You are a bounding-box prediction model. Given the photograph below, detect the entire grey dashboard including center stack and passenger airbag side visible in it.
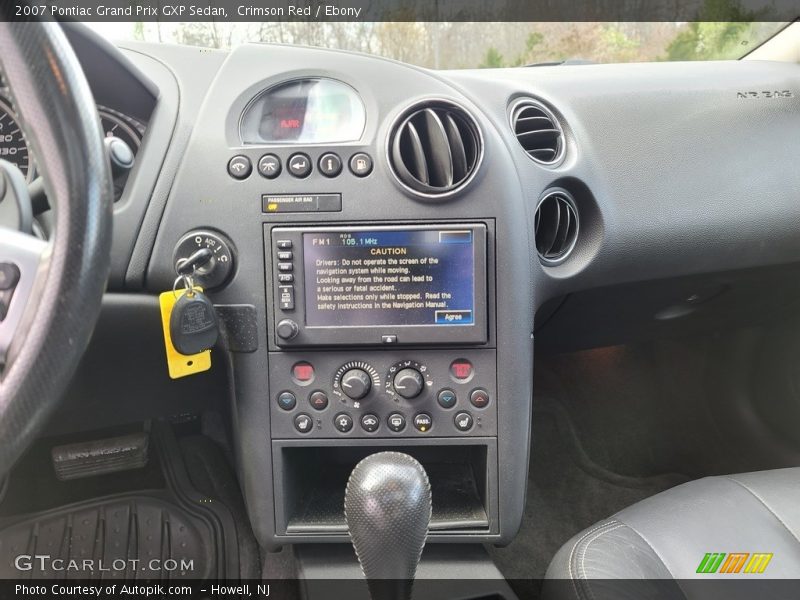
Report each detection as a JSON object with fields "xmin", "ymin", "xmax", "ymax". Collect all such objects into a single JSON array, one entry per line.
[{"xmin": 34, "ymin": 27, "xmax": 800, "ymax": 548}]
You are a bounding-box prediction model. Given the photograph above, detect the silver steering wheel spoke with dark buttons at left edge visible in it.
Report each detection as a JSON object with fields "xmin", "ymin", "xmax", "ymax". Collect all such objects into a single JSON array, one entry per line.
[{"xmin": 0, "ymin": 229, "xmax": 50, "ymax": 366}]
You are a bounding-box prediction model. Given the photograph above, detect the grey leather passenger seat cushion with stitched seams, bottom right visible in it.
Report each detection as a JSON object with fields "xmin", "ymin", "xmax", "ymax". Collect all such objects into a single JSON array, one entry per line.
[{"xmin": 545, "ymin": 468, "xmax": 800, "ymax": 599}]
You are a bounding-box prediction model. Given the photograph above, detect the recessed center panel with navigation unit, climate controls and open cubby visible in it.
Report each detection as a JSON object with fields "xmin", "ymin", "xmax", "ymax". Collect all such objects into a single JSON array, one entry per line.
[{"xmin": 264, "ymin": 221, "xmax": 497, "ymax": 536}]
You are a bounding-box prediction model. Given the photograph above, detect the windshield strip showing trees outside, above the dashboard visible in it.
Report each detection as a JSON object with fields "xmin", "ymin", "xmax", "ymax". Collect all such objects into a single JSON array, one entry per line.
[{"xmin": 88, "ymin": 22, "xmax": 785, "ymax": 69}]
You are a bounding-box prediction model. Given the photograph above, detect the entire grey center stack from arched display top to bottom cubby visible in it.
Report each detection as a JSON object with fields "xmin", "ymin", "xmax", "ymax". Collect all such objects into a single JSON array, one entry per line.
[{"xmin": 147, "ymin": 45, "xmax": 533, "ymax": 548}]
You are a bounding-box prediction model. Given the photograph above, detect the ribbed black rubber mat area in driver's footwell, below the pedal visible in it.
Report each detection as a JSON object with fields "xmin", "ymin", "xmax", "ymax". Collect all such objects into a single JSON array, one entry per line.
[{"xmin": 0, "ymin": 496, "xmax": 216, "ymax": 580}]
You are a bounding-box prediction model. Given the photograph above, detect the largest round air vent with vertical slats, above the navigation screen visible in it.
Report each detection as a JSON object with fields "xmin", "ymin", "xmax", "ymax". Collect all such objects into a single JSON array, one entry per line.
[{"xmin": 389, "ymin": 100, "xmax": 483, "ymax": 198}]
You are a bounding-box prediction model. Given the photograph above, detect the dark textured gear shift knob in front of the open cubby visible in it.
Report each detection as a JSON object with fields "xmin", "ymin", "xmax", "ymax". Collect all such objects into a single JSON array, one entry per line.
[{"xmin": 344, "ymin": 452, "xmax": 431, "ymax": 600}]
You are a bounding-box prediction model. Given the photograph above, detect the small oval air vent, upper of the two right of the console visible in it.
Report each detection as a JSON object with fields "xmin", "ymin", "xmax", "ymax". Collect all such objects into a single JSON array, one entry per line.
[{"xmin": 511, "ymin": 98, "xmax": 566, "ymax": 165}]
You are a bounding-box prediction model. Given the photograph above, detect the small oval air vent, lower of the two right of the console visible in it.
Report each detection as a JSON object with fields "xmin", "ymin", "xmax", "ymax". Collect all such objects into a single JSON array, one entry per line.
[{"xmin": 534, "ymin": 190, "xmax": 579, "ymax": 265}]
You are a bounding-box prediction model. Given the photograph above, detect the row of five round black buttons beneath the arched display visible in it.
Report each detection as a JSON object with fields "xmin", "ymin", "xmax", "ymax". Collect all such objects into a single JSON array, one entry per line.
[{"xmin": 228, "ymin": 152, "xmax": 373, "ymax": 181}]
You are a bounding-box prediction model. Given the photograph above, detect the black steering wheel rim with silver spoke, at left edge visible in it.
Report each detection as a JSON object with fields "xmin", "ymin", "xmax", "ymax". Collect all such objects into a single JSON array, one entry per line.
[{"xmin": 0, "ymin": 24, "xmax": 113, "ymax": 477}]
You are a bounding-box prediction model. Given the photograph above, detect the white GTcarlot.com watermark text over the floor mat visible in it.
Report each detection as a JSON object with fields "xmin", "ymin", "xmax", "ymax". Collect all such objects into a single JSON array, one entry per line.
[{"xmin": 14, "ymin": 554, "xmax": 194, "ymax": 574}]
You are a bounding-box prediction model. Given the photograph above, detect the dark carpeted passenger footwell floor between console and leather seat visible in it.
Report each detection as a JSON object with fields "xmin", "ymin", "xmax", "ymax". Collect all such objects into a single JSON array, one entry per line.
[{"xmin": 490, "ymin": 342, "xmax": 764, "ymax": 598}]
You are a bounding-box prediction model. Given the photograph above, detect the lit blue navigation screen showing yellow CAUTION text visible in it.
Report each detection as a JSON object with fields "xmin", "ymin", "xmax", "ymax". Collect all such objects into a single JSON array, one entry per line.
[{"xmin": 303, "ymin": 229, "xmax": 475, "ymax": 327}]
